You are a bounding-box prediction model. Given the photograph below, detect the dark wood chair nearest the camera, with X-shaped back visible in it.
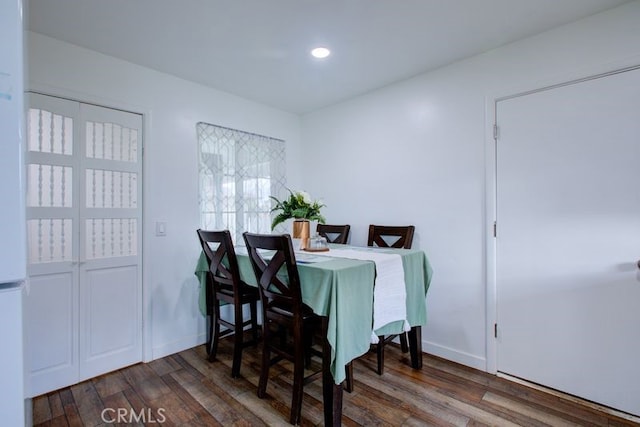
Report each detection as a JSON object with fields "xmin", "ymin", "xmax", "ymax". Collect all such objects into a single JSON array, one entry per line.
[{"xmin": 243, "ymin": 232, "xmax": 322, "ymax": 424}]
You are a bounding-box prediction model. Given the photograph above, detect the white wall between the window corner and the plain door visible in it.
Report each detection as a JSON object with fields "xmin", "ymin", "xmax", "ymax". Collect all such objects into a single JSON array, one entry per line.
[{"xmin": 302, "ymin": 1, "xmax": 640, "ymax": 370}]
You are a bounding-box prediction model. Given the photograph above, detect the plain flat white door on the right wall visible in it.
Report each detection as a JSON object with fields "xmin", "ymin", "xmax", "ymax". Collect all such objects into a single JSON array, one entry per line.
[{"xmin": 496, "ymin": 69, "xmax": 640, "ymax": 415}]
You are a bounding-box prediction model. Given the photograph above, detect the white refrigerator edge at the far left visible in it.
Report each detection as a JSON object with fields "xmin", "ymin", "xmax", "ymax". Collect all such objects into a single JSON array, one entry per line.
[{"xmin": 0, "ymin": 0, "xmax": 27, "ymax": 426}]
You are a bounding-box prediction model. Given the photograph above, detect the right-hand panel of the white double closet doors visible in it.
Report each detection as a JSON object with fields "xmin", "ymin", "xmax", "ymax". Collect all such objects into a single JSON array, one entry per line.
[{"xmin": 79, "ymin": 104, "xmax": 142, "ymax": 380}]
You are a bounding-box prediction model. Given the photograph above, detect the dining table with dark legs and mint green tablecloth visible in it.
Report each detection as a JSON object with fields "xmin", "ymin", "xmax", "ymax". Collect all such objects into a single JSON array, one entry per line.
[{"xmin": 195, "ymin": 244, "xmax": 433, "ymax": 426}]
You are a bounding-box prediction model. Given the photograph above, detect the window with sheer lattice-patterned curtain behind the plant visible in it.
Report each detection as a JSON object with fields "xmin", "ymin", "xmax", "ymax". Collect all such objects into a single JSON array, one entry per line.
[{"xmin": 196, "ymin": 122, "xmax": 285, "ymax": 242}]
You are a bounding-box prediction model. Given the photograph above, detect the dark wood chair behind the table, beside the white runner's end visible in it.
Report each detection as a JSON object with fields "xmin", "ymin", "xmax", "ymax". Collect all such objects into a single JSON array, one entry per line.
[{"xmin": 367, "ymin": 224, "xmax": 415, "ymax": 375}]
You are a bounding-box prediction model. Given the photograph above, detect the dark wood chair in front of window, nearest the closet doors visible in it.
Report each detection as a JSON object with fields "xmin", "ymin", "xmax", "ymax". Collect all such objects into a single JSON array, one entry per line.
[{"xmin": 197, "ymin": 229, "xmax": 260, "ymax": 378}]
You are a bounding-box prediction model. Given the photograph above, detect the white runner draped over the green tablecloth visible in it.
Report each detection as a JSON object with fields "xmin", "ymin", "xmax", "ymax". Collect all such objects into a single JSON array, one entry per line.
[{"xmin": 318, "ymin": 248, "xmax": 411, "ymax": 344}]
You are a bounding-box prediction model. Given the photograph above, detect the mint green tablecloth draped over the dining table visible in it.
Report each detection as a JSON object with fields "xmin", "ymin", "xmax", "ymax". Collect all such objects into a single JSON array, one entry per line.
[{"xmin": 195, "ymin": 245, "xmax": 432, "ymax": 384}]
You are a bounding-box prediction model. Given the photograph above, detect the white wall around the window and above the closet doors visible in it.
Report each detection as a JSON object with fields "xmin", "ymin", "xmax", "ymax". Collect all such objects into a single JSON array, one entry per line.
[{"xmin": 26, "ymin": 33, "xmax": 301, "ymax": 360}]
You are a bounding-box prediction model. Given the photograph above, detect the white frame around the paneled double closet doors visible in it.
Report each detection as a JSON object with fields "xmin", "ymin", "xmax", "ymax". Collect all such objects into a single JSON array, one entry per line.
[{"xmin": 25, "ymin": 84, "xmax": 153, "ymax": 363}]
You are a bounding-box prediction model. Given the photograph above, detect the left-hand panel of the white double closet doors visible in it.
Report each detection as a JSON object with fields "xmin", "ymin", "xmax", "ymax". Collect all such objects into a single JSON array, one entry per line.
[{"xmin": 24, "ymin": 95, "xmax": 80, "ymax": 396}]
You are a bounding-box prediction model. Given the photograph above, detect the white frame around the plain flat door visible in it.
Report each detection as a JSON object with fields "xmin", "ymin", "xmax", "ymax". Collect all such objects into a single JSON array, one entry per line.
[{"xmin": 484, "ymin": 56, "xmax": 640, "ymax": 374}]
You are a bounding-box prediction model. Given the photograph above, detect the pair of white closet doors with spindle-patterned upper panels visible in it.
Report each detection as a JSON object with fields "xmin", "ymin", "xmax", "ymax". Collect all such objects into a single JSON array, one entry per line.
[{"xmin": 25, "ymin": 94, "xmax": 142, "ymax": 396}]
